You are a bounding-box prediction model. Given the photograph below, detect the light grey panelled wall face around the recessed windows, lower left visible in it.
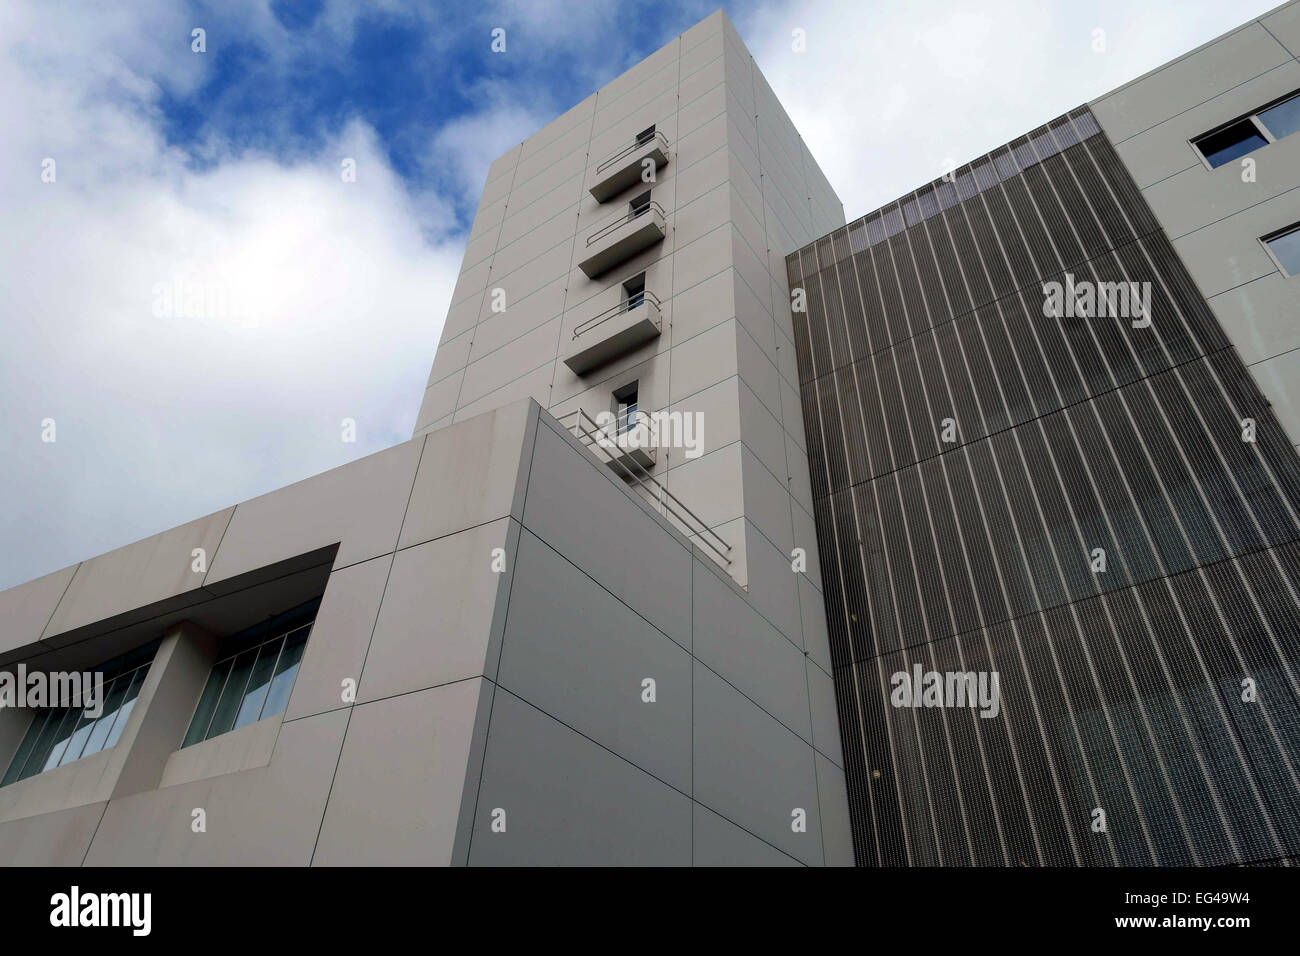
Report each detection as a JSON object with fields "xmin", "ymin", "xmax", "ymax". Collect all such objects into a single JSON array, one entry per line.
[{"xmin": 0, "ymin": 403, "xmax": 540, "ymax": 865}]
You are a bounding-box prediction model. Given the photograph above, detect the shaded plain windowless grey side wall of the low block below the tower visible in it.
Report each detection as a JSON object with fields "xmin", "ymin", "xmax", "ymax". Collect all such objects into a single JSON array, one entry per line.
[{"xmin": 469, "ymin": 403, "xmax": 853, "ymax": 865}]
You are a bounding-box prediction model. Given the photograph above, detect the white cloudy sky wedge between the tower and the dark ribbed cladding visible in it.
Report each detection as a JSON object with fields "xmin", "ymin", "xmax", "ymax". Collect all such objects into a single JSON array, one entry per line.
[{"xmin": 736, "ymin": 0, "xmax": 1277, "ymax": 220}]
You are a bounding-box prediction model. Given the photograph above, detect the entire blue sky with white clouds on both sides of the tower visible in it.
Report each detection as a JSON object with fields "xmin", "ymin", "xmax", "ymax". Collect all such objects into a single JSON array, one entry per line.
[{"xmin": 0, "ymin": 0, "xmax": 1274, "ymax": 588}]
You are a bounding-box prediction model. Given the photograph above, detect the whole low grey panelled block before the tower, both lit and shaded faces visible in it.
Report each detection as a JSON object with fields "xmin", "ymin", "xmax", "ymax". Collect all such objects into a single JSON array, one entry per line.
[{"xmin": 0, "ymin": 401, "xmax": 852, "ymax": 865}]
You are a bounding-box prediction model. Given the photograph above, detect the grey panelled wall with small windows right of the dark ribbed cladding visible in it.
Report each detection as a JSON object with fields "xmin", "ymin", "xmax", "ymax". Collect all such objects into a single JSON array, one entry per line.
[{"xmin": 1091, "ymin": 1, "xmax": 1300, "ymax": 445}]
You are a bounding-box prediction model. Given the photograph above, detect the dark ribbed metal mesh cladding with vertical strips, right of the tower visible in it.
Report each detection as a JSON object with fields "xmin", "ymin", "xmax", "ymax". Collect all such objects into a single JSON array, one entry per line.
[{"xmin": 787, "ymin": 108, "xmax": 1300, "ymax": 866}]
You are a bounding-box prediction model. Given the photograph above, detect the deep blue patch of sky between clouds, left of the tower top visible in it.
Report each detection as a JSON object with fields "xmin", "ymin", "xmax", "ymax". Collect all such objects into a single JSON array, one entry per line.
[{"xmin": 155, "ymin": 0, "xmax": 716, "ymax": 231}]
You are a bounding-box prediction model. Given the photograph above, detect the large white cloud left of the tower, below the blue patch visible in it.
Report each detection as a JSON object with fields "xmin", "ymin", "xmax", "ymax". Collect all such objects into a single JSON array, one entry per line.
[{"xmin": 0, "ymin": 4, "xmax": 462, "ymax": 588}]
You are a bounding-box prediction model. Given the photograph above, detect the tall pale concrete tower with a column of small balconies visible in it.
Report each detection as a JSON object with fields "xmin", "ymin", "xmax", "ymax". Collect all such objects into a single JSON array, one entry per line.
[{"xmin": 416, "ymin": 10, "xmax": 844, "ymax": 647}]
